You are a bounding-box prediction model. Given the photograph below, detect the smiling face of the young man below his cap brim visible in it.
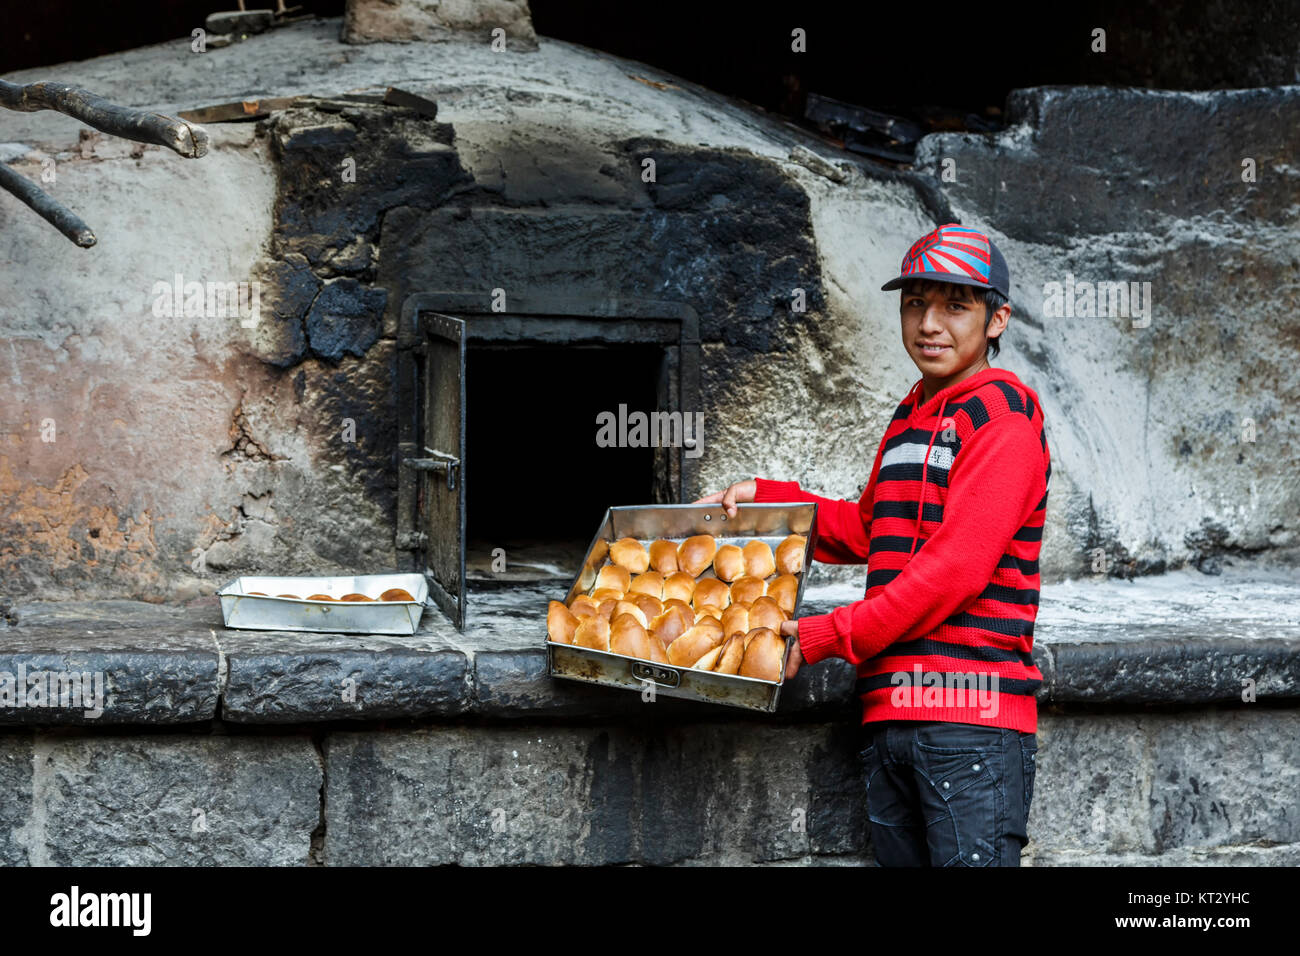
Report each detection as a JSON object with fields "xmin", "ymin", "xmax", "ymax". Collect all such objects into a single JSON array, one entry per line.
[{"xmin": 900, "ymin": 284, "xmax": 993, "ymax": 382}]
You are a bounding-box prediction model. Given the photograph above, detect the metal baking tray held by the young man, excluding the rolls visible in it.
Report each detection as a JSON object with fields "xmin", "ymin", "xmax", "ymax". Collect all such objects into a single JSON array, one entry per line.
[{"xmin": 546, "ymin": 502, "xmax": 816, "ymax": 713}]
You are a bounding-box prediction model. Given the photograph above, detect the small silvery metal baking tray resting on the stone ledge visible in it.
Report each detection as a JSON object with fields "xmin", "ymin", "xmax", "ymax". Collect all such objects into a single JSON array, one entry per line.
[{"xmin": 217, "ymin": 574, "xmax": 429, "ymax": 633}]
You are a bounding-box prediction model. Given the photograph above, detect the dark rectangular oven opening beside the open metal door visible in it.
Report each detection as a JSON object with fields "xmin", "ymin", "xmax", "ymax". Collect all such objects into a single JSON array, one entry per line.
[{"xmin": 465, "ymin": 342, "xmax": 676, "ymax": 589}]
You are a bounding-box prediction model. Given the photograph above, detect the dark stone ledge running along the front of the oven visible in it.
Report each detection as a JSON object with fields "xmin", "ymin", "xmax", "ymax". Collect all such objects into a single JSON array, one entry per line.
[{"xmin": 0, "ymin": 598, "xmax": 1300, "ymax": 724}]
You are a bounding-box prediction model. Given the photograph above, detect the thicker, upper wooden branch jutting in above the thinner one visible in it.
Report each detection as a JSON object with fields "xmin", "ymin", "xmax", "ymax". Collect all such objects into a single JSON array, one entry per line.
[{"xmin": 0, "ymin": 79, "xmax": 208, "ymax": 158}]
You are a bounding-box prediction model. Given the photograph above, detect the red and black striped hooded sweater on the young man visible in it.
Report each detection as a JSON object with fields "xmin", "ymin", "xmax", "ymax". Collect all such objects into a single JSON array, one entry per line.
[{"xmin": 754, "ymin": 368, "xmax": 1052, "ymax": 734}]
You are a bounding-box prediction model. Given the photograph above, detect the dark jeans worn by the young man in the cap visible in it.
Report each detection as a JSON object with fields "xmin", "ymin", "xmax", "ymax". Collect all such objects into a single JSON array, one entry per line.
[{"xmin": 858, "ymin": 721, "xmax": 1039, "ymax": 866}]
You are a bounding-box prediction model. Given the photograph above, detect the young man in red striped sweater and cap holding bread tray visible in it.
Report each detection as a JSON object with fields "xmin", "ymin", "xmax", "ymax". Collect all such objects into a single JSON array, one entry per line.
[{"xmin": 699, "ymin": 224, "xmax": 1052, "ymax": 866}]
